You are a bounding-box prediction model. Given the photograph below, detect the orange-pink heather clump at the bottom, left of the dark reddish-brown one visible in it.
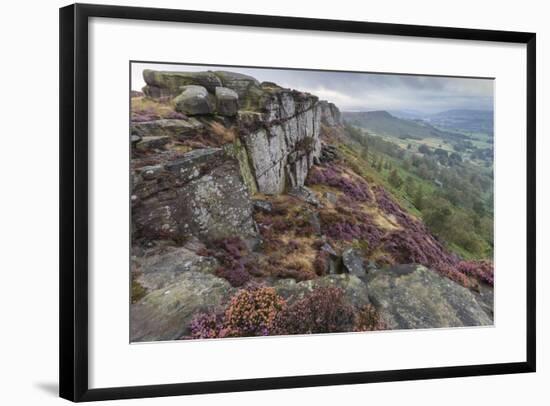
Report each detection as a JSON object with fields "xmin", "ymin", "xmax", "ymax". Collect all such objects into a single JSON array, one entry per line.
[{"xmin": 224, "ymin": 287, "xmax": 286, "ymax": 337}]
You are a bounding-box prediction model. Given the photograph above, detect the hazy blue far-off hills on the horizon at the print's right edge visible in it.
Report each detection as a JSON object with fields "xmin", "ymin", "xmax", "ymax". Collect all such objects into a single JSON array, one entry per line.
[{"xmin": 423, "ymin": 109, "xmax": 494, "ymax": 135}]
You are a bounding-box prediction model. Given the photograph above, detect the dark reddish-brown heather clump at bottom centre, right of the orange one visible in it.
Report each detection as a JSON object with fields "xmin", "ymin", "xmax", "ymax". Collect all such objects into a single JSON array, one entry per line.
[{"xmin": 273, "ymin": 287, "xmax": 354, "ymax": 334}]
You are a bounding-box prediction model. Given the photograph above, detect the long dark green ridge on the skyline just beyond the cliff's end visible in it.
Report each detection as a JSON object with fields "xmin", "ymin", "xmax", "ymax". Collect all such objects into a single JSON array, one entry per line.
[{"xmin": 343, "ymin": 111, "xmax": 463, "ymax": 140}]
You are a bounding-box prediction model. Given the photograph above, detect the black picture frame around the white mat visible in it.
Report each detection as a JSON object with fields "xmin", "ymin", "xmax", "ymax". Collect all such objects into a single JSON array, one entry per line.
[{"xmin": 59, "ymin": 4, "xmax": 536, "ymax": 402}]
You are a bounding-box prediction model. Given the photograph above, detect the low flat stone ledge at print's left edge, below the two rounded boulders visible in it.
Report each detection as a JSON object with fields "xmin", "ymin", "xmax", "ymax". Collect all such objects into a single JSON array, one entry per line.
[{"xmin": 131, "ymin": 118, "xmax": 204, "ymax": 139}]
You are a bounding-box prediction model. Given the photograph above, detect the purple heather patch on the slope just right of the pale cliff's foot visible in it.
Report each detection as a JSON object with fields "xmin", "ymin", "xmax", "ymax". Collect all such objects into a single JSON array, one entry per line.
[{"xmin": 306, "ymin": 164, "xmax": 371, "ymax": 202}]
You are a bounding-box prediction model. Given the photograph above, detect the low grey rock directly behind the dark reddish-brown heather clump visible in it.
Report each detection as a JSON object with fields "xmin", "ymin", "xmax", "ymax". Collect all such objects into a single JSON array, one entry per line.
[{"xmin": 273, "ymin": 274, "xmax": 370, "ymax": 308}]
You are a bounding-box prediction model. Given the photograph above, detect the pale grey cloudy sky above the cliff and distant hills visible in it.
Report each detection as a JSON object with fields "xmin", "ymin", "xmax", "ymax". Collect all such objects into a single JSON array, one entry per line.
[{"xmin": 132, "ymin": 63, "xmax": 494, "ymax": 113}]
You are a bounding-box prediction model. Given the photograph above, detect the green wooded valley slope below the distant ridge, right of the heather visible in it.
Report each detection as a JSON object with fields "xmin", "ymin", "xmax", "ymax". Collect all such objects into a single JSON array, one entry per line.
[{"xmin": 339, "ymin": 125, "xmax": 493, "ymax": 259}]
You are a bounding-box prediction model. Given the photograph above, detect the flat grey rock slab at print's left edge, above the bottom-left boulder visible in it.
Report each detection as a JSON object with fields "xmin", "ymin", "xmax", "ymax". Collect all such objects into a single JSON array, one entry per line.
[{"xmin": 132, "ymin": 247, "xmax": 219, "ymax": 290}]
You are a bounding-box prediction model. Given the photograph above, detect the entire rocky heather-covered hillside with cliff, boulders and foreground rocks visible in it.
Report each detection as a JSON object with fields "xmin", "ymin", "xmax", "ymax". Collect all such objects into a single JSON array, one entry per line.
[{"xmin": 131, "ymin": 71, "xmax": 493, "ymax": 341}]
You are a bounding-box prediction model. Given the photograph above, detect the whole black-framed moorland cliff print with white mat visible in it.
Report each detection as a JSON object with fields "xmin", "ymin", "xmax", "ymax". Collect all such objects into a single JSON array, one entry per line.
[{"xmin": 60, "ymin": 4, "xmax": 536, "ymax": 401}]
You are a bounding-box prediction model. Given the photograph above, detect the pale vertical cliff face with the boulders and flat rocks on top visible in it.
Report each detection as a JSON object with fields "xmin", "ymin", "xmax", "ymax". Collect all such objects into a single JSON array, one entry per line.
[{"xmin": 134, "ymin": 70, "xmax": 339, "ymax": 194}]
